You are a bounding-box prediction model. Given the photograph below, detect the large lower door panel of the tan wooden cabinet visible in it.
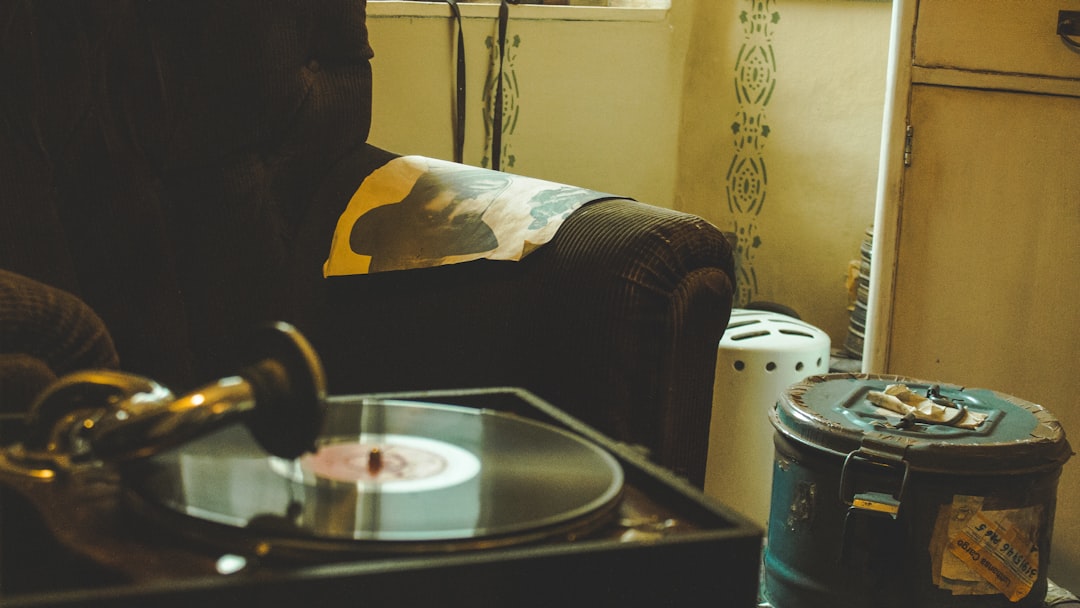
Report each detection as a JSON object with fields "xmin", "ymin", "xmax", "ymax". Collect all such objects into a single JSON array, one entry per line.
[{"xmin": 888, "ymin": 84, "xmax": 1080, "ymax": 411}]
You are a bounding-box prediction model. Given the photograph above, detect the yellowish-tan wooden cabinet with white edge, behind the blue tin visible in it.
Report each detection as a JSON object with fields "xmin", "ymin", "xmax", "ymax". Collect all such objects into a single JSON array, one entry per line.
[{"xmin": 864, "ymin": 0, "xmax": 1080, "ymax": 585}]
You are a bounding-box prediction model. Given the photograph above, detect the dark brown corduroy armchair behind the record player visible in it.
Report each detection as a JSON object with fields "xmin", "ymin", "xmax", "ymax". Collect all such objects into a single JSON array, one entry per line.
[{"xmin": 0, "ymin": 0, "xmax": 733, "ymax": 485}]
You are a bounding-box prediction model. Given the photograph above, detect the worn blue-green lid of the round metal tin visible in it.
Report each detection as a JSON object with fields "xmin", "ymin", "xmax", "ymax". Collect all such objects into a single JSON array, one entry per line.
[{"xmin": 770, "ymin": 374, "xmax": 1072, "ymax": 474}]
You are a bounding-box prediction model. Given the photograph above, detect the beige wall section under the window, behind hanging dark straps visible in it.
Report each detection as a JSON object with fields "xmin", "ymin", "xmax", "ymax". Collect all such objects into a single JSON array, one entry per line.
[{"xmin": 368, "ymin": 6, "xmax": 681, "ymax": 207}]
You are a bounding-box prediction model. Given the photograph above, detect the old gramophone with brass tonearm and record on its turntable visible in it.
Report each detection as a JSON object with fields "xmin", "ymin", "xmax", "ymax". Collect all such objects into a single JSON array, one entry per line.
[{"xmin": 0, "ymin": 324, "xmax": 761, "ymax": 607}]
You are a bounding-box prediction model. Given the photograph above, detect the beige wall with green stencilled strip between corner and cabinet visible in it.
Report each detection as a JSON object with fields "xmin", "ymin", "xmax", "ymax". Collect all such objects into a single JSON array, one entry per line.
[{"xmin": 677, "ymin": 0, "xmax": 891, "ymax": 346}]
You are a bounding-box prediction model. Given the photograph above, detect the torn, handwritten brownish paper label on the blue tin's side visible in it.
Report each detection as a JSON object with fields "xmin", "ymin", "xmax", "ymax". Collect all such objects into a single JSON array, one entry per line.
[{"xmin": 931, "ymin": 496, "xmax": 1042, "ymax": 602}]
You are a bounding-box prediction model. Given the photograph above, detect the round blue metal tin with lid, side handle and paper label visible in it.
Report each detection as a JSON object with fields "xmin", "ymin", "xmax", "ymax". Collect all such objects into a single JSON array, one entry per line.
[{"xmin": 764, "ymin": 374, "xmax": 1071, "ymax": 608}]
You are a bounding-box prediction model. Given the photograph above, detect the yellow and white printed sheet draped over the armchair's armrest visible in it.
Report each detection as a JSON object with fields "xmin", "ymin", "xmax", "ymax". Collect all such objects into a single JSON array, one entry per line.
[{"xmin": 323, "ymin": 157, "xmax": 612, "ymax": 276}]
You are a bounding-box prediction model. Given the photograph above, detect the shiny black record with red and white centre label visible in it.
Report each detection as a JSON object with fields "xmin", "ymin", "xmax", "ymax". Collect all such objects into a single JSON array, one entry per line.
[{"xmin": 124, "ymin": 402, "xmax": 623, "ymax": 553}]
